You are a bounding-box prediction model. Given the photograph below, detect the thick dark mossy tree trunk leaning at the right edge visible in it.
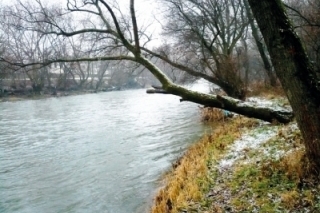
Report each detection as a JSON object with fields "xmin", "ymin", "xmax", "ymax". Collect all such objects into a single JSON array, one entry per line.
[{"xmin": 249, "ymin": 0, "xmax": 320, "ymax": 171}]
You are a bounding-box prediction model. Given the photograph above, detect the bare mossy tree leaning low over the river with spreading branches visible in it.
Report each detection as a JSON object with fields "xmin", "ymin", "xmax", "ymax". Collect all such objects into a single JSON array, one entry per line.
[{"xmin": 2, "ymin": 0, "xmax": 293, "ymax": 123}]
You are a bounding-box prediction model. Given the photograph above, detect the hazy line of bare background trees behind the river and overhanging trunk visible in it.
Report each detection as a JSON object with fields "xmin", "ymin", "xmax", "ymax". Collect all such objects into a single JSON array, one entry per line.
[{"xmin": 0, "ymin": 0, "xmax": 320, "ymax": 100}]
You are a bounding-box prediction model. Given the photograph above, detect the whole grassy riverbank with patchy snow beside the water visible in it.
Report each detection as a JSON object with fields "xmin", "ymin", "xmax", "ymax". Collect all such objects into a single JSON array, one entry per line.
[{"xmin": 151, "ymin": 85, "xmax": 320, "ymax": 213}]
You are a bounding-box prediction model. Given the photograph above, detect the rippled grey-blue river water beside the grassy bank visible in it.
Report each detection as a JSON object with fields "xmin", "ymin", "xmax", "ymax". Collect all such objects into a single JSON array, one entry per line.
[{"xmin": 0, "ymin": 90, "xmax": 204, "ymax": 213}]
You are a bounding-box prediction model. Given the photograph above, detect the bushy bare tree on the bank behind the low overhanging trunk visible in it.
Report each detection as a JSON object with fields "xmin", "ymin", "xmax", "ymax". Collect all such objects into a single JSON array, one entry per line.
[{"xmin": 149, "ymin": 0, "xmax": 248, "ymax": 99}]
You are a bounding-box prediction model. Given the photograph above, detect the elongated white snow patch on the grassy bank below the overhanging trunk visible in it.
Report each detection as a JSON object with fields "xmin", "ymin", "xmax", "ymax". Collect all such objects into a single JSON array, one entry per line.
[{"xmin": 217, "ymin": 125, "xmax": 279, "ymax": 171}]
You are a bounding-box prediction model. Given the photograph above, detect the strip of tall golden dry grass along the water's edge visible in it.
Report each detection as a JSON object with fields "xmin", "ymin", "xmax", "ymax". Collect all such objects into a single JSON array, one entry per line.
[{"xmin": 151, "ymin": 117, "xmax": 257, "ymax": 213}]
